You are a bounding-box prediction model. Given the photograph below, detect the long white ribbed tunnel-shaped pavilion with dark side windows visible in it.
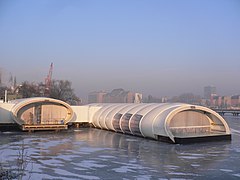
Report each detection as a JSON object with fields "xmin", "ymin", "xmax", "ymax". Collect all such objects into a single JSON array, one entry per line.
[{"xmin": 89, "ymin": 103, "xmax": 230, "ymax": 142}]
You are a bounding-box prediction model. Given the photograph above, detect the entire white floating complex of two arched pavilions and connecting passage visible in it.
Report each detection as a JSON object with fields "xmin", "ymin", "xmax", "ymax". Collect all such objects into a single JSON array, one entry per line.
[{"xmin": 0, "ymin": 97, "xmax": 231, "ymax": 143}]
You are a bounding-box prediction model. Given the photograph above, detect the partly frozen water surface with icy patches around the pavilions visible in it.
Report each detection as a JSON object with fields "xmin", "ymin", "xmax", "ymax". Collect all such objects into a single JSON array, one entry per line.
[{"xmin": 0, "ymin": 116, "xmax": 240, "ymax": 179}]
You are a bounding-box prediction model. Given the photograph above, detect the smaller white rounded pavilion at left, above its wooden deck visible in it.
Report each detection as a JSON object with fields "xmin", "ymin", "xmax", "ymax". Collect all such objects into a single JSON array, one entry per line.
[{"xmin": 11, "ymin": 97, "xmax": 73, "ymax": 125}]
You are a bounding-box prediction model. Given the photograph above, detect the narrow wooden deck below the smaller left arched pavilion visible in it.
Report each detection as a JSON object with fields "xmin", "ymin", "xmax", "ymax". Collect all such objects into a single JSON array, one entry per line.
[{"xmin": 21, "ymin": 124, "xmax": 68, "ymax": 131}]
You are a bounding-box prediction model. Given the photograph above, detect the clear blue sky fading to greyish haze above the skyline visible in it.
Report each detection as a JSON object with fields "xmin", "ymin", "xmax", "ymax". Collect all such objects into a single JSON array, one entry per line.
[{"xmin": 0, "ymin": 0, "xmax": 240, "ymax": 98}]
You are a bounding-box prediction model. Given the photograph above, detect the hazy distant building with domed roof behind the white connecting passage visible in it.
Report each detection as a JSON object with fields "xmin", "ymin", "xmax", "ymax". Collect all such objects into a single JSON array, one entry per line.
[{"xmin": 88, "ymin": 88, "xmax": 142, "ymax": 103}]
